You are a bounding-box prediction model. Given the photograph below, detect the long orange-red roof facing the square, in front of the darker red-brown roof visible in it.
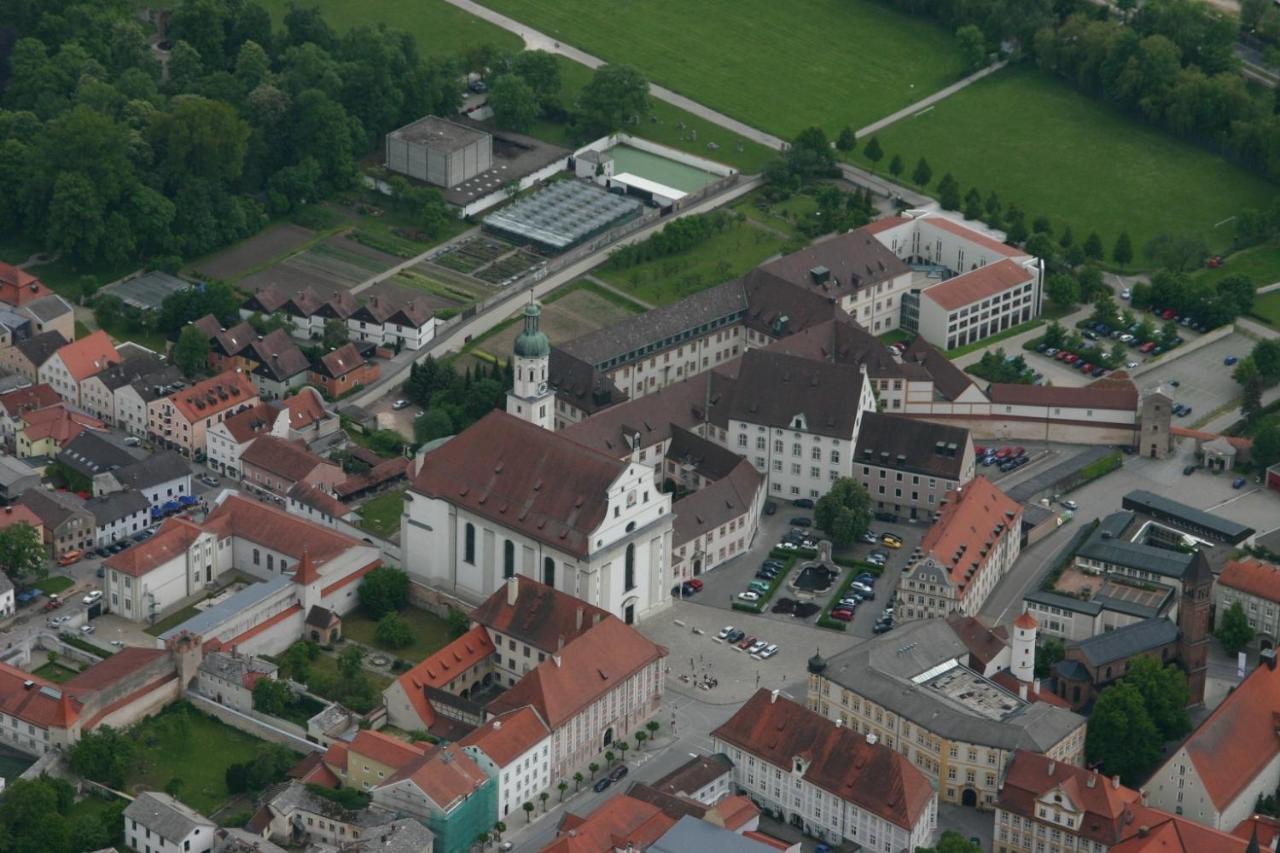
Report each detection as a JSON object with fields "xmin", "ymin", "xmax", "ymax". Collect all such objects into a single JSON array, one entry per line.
[{"xmin": 488, "ymin": 616, "xmax": 667, "ymax": 729}]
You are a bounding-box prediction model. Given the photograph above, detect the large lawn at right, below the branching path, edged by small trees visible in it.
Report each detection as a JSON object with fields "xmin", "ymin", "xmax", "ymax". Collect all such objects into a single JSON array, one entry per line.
[{"xmin": 859, "ymin": 68, "xmax": 1276, "ymax": 266}]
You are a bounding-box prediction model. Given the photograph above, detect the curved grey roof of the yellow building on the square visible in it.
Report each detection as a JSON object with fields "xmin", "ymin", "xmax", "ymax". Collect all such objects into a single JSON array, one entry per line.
[{"xmin": 823, "ymin": 619, "xmax": 1084, "ymax": 752}]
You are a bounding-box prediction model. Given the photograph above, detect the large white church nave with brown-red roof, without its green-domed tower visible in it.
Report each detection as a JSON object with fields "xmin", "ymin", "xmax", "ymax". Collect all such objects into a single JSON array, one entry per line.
[{"xmin": 401, "ymin": 411, "xmax": 673, "ymax": 624}]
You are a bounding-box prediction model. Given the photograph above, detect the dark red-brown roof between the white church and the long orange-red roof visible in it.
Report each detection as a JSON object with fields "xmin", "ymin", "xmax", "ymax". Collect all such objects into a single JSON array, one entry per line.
[{"xmin": 471, "ymin": 575, "xmax": 609, "ymax": 652}]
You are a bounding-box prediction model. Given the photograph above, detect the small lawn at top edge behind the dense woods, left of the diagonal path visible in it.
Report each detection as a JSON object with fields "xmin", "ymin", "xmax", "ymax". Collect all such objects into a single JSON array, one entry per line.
[{"xmin": 260, "ymin": 0, "xmax": 521, "ymax": 56}]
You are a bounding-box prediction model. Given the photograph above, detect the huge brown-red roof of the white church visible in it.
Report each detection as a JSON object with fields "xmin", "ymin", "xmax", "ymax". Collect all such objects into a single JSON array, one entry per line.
[{"xmin": 412, "ymin": 411, "xmax": 626, "ymax": 557}]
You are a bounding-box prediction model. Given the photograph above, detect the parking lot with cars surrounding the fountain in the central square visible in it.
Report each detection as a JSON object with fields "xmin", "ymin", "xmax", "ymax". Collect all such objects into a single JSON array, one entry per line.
[{"xmin": 690, "ymin": 503, "xmax": 927, "ymax": 637}]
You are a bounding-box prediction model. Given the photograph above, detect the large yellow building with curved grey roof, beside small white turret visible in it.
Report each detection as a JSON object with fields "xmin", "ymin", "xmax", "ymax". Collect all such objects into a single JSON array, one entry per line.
[{"xmin": 808, "ymin": 616, "xmax": 1085, "ymax": 809}]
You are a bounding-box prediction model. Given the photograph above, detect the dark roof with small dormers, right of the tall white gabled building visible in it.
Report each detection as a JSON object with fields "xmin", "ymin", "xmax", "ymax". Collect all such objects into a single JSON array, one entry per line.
[{"xmin": 854, "ymin": 412, "xmax": 969, "ymax": 480}]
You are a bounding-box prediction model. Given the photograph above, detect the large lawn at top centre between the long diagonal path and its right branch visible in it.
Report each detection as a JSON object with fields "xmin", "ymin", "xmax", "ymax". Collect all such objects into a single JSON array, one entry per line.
[{"xmin": 481, "ymin": 0, "xmax": 964, "ymax": 137}]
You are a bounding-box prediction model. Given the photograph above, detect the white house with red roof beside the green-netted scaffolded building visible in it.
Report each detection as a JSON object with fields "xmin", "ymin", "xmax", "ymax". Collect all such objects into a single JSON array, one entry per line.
[{"xmin": 458, "ymin": 701, "xmax": 554, "ymax": 821}]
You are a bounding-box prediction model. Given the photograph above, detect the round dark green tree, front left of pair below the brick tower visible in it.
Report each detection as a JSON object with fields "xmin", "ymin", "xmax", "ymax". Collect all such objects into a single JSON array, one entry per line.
[{"xmin": 1084, "ymin": 679, "xmax": 1164, "ymax": 785}]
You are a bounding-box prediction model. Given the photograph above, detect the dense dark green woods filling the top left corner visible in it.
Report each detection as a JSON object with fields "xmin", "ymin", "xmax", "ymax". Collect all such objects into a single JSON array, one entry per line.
[{"xmin": 0, "ymin": 0, "xmax": 461, "ymax": 265}]
